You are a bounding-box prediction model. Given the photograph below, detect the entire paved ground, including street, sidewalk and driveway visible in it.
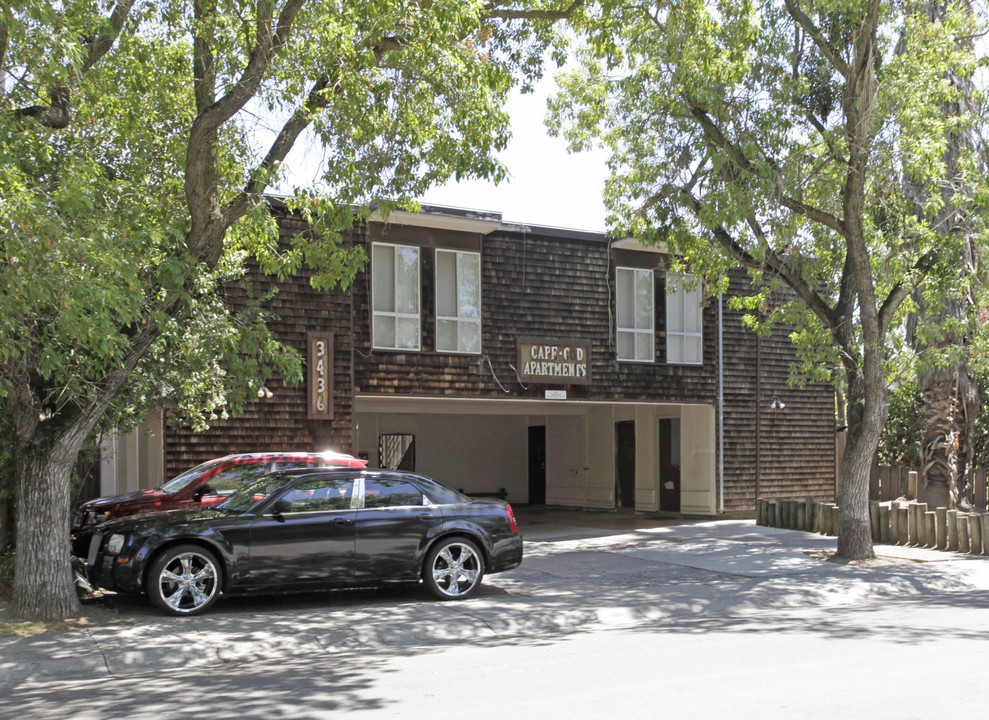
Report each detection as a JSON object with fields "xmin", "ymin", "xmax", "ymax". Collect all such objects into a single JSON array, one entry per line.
[{"xmin": 0, "ymin": 512, "xmax": 989, "ymax": 719}]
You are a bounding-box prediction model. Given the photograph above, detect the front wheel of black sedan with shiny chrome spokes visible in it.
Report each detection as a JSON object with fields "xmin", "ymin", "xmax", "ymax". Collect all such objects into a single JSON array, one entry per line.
[{"xmin": 145, "ymin": 545, "xmax": 222, "ymax": 615}]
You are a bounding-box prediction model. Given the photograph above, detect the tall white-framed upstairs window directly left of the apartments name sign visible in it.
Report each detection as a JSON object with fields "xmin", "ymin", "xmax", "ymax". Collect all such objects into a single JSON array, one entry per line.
[{"xmin": 436, "ymin": 250, "xmax": 481, "ymax": 353}]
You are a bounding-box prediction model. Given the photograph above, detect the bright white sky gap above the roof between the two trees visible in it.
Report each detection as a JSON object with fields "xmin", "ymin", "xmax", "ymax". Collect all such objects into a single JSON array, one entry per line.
[{"xmin": 419, "ymin": 73, "xmax": 607, "ymax": 232}]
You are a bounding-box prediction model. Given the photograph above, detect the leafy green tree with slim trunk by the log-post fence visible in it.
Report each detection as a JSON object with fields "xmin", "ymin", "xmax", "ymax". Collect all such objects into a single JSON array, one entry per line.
[{"xmin": 551, "ymin": 0, "xmax": 986, "ymax": 558}]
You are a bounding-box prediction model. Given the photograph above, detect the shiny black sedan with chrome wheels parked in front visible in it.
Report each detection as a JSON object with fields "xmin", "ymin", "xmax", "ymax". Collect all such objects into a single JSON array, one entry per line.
[{"xmin": 86, "ymin": 469, "xmax": 522, "ymax": 615}]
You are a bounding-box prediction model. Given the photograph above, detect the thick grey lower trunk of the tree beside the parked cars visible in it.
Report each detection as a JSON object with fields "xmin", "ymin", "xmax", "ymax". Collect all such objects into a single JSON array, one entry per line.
[{"xmin": 11, "ymin": 439, "xmax": 81, "ymax": 620}]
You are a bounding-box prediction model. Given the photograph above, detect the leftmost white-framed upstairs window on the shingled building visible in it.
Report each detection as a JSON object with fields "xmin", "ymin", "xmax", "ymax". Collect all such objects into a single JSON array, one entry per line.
[{"xmin": 371, "ymin": 243, "xmax": 420, "ymax": 350}]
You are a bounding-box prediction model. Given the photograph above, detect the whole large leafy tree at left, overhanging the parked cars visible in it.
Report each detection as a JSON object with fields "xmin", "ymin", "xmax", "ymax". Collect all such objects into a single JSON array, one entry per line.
[{"xmin": 0, "ymin": 0, "xmax": 582, "ymax": 618}]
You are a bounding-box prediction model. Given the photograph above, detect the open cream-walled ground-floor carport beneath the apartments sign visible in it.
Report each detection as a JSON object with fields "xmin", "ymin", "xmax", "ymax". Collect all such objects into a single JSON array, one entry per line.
[{"xmin": 354, "ymin": 394, "xmax": 717, "ymax": 515}]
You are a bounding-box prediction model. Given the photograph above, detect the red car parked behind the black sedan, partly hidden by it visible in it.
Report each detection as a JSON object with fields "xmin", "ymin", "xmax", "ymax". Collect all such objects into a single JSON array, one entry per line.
[{"xmin": 72, "ymin": 452, "xmax": 367, "ymax": 557}]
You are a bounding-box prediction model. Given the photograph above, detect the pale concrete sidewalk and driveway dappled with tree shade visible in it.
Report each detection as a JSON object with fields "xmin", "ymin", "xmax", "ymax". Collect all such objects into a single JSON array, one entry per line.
[{"xmin": 0, "ymin": 509, "xmax": 989, "ymax": 688}]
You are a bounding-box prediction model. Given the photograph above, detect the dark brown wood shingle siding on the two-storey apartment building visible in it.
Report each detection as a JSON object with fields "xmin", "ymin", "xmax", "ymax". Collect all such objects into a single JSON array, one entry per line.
[{"xmin": 165, "ymin": 205, "xmax": 835, "ymax": 513}]
